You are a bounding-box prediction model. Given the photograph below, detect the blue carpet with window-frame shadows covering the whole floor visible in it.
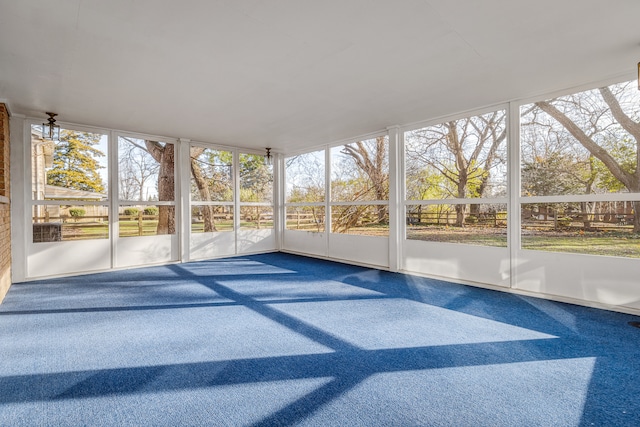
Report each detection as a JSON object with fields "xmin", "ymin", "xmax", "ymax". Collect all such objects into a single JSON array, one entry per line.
[{"xmin": 0, "ymin": 254, "xmax": 640, "ymax": 426}]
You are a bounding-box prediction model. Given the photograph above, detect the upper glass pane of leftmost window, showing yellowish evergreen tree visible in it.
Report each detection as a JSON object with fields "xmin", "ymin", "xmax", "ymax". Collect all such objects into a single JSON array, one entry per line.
[{"xmin": 31, "ymin": 125, "xmax": 109, "ymax": 200}]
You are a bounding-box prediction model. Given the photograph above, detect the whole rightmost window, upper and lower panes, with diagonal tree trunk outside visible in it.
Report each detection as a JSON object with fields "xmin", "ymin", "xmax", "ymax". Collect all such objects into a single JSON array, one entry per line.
[{"xmin": 520, "ymin": 81, "xmax": 640, "ymax": 257}]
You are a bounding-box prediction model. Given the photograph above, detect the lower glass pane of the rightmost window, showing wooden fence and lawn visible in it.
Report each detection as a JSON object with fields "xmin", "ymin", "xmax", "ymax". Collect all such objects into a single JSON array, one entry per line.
[{"xmin": 521, "ymin": 201, "xmax": 640, "ymax": 258}]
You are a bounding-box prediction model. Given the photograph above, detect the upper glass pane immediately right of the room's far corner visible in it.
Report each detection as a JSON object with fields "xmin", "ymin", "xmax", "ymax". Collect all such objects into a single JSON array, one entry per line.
[{"xmin": 285, "ymin": 151, "xmax": 325, "ymax": 203}]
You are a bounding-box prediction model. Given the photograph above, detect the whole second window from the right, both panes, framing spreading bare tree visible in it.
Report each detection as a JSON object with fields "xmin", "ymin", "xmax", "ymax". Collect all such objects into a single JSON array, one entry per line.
[{"xmin": 405, "ymin": 110, "xmax": 507, "ymax": 247}]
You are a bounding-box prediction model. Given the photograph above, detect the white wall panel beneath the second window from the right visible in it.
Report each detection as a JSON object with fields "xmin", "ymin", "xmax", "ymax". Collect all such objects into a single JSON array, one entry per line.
[{"xmin": 403, "ymin": 240, "xmax": 510, "ymax": 287}]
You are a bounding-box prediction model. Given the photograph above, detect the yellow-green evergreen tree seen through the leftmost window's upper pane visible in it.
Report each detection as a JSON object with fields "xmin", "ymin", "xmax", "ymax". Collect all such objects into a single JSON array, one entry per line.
[{"xmin": 47, "ymin": 129, "xmax": 105, "ymax": 193}]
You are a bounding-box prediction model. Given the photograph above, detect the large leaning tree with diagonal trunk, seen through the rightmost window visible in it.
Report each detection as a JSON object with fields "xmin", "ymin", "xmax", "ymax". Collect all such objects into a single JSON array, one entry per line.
[{"xmin": 535, "ymin": 82, "xmax": 640, "ymax": 233}]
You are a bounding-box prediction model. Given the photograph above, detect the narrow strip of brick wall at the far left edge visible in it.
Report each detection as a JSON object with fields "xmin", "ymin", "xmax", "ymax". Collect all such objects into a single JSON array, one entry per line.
[{"xmin": 0, "ymin": 104, "xmax": 11, "ymax": 302}]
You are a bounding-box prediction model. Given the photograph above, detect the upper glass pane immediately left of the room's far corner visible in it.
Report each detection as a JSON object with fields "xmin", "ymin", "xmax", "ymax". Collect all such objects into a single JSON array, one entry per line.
[{"xmin": 240, "ymin": 154, "xmax": 273, "ymax": 203}]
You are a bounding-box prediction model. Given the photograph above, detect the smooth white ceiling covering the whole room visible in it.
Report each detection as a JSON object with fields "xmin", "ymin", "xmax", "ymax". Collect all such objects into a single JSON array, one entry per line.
[{"xmin": 0, "ymin": 0, "xmax": 640, "ymax": 152}]
